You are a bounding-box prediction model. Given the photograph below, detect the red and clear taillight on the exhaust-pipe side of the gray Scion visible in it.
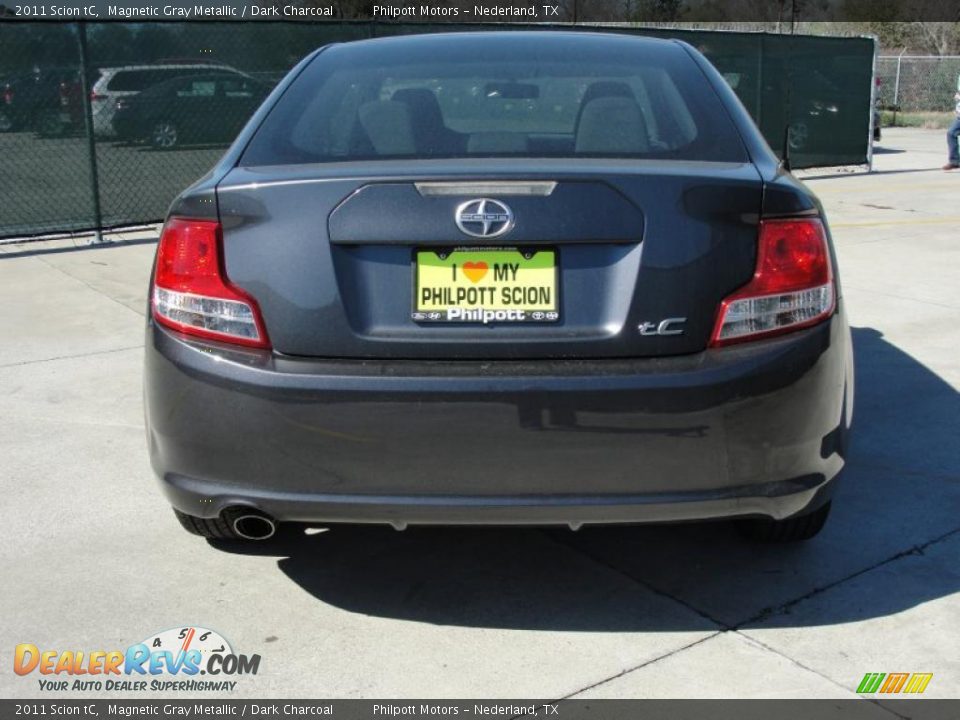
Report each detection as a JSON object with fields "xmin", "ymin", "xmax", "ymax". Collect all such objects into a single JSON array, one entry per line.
[{"xmin": 152, "ymin": 218, "xmax": 270, "ymax": 348}]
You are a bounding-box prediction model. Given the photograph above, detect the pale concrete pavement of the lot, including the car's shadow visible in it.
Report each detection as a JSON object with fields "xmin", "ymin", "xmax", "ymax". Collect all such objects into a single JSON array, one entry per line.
[{"xmin": 0, "ymin": 129, "xmax": 960, "ymax": 700}]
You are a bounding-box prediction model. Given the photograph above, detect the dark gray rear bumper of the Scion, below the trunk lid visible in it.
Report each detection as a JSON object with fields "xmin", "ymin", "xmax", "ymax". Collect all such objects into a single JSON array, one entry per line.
[{"xmin": 145, "ymin": 311, "xmax": 852, "ymax": 527}]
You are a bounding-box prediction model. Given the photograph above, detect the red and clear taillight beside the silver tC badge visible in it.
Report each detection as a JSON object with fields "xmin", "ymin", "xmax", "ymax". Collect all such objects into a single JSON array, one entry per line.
[{"xmin": 710, "ymin": 218, "xmax": 836, "ymax": 347}]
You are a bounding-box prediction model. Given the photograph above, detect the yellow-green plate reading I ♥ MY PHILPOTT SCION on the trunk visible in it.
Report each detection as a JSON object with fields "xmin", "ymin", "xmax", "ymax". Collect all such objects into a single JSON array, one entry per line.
[{"xmin": 411, "ymin": 248, "xmax": 560, "ymax": 324}]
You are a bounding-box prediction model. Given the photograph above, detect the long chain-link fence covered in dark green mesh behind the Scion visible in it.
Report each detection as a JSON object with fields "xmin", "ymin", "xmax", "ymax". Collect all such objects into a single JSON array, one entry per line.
[{"xmin": 0, "ymin": 22, "xmax": 874, "ymax": 238}]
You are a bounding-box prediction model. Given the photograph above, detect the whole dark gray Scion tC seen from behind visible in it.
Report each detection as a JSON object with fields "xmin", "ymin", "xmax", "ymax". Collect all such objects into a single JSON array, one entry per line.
[{"xmin": 145, "ymin": 31, "xmax": 853, "ymax": 540}]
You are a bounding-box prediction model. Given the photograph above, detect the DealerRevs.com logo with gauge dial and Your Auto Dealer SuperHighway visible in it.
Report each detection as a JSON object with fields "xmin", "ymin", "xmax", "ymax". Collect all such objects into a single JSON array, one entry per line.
[{"xmin": 13, "ymin": 627, "xmax": 260, "ymax": 692}]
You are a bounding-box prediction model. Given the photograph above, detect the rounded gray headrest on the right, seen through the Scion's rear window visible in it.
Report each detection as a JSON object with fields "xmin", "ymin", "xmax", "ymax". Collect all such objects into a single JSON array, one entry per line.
[{"xmin": 576, "ymin": 97, "xmax": 650, "ymax": 154}]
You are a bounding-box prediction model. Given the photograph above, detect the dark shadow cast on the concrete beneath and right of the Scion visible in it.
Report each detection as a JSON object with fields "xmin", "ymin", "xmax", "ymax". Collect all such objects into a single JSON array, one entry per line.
[{"xmin": 212, "ymin": 328, "xmax": 960, "ymax": 632}]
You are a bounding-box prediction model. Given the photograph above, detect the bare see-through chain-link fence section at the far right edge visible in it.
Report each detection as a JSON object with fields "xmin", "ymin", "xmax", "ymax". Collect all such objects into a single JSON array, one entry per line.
[{"xmin": 877, "ymin": 55, "xmax": 960, "ymax": 112}]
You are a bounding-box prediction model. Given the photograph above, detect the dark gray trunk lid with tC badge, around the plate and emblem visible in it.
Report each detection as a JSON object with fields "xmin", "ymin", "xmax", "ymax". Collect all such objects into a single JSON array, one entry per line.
[{"xmin": 218, "ymin": 159, "xmax": 762, "ymax": 359}]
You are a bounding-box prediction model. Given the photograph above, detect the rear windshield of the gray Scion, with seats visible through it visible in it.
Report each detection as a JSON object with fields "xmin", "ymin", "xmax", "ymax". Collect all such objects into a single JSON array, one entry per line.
[{"xmin": 241, "ymin": 34, "xmax": 746, "ymax": 166}]
